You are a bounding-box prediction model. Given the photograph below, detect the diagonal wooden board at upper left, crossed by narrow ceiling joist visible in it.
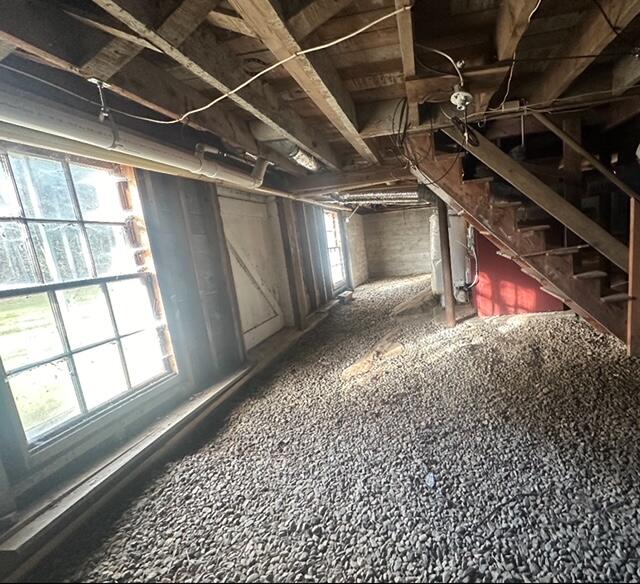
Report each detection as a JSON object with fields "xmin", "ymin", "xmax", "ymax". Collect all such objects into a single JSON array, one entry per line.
[{"xmin": 82, "ymin": 0, "xmax": 219, "ymax": 81}]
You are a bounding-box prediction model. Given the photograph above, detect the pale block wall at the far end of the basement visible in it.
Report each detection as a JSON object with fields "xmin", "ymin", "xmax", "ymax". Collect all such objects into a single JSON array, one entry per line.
[{"xmin": 362, "ymin": 209, "xmax": 435, "ymax": 278}]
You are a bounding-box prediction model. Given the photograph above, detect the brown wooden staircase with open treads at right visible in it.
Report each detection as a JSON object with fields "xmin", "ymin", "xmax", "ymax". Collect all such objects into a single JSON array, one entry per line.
[{"xmin": 420, "ymin": 155, "xmax": 631, "ymax": 341}]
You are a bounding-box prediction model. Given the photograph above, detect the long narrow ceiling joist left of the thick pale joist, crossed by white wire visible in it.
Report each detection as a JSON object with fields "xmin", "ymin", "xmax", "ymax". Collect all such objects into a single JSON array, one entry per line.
[{"xmin": 93, "ymin": 0, "xmax": 338, "ymax": 169}]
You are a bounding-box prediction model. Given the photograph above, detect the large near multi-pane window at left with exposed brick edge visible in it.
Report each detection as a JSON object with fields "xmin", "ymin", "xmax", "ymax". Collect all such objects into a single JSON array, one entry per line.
[{"xmin": 0, "ymin": 150, "xmax": 175, "ymax": 443}]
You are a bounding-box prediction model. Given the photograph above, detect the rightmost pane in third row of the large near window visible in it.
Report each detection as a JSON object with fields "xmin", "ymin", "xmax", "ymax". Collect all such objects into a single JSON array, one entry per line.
[{"xmin": 108, "ymin": 278, "xmax": 157, "ymax": 335}]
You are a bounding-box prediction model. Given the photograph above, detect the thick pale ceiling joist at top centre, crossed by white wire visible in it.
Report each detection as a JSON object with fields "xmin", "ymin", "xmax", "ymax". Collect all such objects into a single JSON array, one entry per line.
[{"xmin": 231, "ymin": 0, "xmax": 378, "ymax": 163}]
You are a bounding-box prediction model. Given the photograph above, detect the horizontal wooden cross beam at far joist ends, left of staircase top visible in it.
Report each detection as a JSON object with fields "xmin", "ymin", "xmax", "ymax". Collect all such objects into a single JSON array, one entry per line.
[{"xmin": 289, "ymin": 166, "xmax": 413, "ymax": 194}]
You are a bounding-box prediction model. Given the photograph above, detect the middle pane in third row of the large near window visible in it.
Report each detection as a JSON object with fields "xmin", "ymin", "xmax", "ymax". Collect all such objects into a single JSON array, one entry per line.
[{"xmin": 56, "ymin": 286, "xmax": 115, "ymax": 349}]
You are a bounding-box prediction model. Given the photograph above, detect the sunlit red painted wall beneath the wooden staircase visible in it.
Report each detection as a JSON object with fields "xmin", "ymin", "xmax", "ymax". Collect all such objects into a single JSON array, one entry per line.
[{"xmin": 473, "ymin": 233, "xmax": 563, "ymax": 316}]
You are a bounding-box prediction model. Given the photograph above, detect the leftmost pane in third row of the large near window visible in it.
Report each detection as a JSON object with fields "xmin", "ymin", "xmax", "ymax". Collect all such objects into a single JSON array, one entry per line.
[{"xmin": 0, "ymin": 294, "xmax": 63, "ymax": 371}]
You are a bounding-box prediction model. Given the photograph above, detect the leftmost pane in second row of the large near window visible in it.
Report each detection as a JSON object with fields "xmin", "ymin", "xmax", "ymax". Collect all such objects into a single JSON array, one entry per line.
[{"xmin": 0, "ymin": 221, "xmax": 38, "ymax": 290}]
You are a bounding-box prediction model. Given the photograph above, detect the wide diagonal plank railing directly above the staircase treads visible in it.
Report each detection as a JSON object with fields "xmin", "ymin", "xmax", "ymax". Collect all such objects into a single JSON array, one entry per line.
[{"xmin": 444, "ymin": 122, "xmax": 629, "ymax": 271}]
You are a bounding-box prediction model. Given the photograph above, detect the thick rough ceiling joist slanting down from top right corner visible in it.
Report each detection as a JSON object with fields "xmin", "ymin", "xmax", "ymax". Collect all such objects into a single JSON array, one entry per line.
[{"xmin": 529, "ymin": 0, "xmax": 640, "ymax": 104}]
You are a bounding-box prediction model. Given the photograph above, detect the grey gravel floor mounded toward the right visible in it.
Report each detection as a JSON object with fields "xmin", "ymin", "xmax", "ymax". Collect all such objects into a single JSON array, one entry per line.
[{"xmin": 34, "ymin": 278, "xmax": 640, "ymax": 582}]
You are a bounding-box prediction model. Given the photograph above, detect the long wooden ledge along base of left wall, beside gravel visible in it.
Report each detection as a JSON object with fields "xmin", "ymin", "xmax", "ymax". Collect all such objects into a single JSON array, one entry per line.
[{"xmin": 0, "ymin": 310, "xmax": 335, "ymax": 581}]
